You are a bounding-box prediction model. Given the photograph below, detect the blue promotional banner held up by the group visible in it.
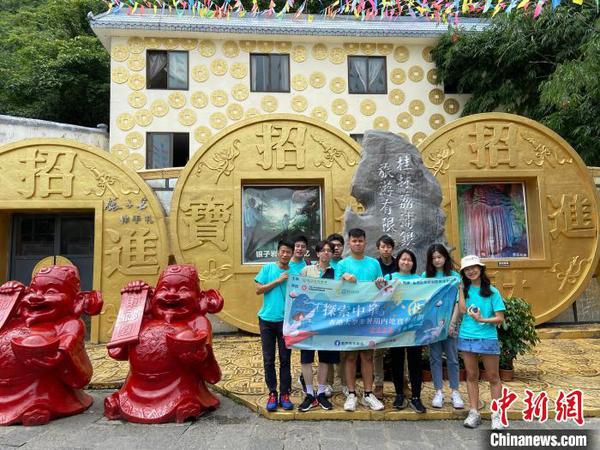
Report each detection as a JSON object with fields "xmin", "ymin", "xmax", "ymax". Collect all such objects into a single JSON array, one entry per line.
[{"xmin": 283, "ymin": 275, "xmax": 459, "ymax": 350}]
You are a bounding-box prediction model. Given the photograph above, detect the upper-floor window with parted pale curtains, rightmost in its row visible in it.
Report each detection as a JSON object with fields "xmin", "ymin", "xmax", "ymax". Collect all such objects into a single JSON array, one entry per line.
[{"xmin": 348, "ymin": 56, "xmax": 387, "ymax": 94}]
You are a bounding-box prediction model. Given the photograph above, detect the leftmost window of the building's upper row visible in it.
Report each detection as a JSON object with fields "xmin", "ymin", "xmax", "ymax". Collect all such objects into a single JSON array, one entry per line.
[{"xmin": 146, "ymin": 50, "xmax": 188, "ymax": 90}]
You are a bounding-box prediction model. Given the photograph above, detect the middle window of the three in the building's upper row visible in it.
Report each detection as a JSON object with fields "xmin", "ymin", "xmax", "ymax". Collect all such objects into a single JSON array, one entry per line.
[{"xmin": 250, "ymin": 53, "xmax": 290, "ymax": 92}]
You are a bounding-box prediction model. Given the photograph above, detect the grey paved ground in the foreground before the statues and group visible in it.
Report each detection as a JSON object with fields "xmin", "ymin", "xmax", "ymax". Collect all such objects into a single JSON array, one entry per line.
[{"xmin": 0, "ymin": 391, "xmax": 600, "ymax": 450}]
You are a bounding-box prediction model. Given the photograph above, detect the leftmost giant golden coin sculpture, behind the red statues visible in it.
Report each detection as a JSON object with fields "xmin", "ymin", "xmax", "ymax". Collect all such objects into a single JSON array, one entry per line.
[{"xmin": 0, "ymin": 139, "xmax": 169, "ymax": 342}]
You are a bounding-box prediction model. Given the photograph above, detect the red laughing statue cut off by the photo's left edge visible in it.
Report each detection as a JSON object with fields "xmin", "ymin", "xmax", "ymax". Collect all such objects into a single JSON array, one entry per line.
[{"xmin": 0, "ymin": 266, "xmax": 102, "ymax": 425}]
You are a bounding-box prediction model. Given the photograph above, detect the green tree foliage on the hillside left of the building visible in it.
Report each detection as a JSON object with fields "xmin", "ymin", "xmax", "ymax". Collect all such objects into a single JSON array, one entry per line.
[{"xmin": 0, "ymin": 0, "xmax": 110, "ymax": 126}]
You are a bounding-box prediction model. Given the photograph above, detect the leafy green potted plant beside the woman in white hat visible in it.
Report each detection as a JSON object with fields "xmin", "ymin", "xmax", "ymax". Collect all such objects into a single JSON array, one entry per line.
[{"xmin": 498, "ymin": 297, "xmax": 540, "ymax": 381}]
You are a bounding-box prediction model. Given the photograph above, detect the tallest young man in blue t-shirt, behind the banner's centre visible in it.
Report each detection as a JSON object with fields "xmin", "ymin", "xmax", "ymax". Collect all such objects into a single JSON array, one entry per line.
[{"xmin": 335, "ymin": 228, "xmax": 384, "ymax": 411}]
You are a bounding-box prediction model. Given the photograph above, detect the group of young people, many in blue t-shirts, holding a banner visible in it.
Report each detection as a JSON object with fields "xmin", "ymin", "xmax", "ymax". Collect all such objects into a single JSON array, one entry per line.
[{"xmin": 255, "ymin": 228, "xmax": 504, "ymax": 429}]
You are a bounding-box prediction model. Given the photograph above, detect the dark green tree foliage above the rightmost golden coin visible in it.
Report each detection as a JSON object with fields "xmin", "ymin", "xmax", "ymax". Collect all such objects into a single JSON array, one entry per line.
[{"xmin": 432, "ymin": 4, "xmax": 600, "ymax": 165}]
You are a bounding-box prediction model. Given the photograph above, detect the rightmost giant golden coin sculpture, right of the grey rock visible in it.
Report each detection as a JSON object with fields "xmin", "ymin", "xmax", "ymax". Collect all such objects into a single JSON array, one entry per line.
[{"xmin": 419, "ymin": 113, "xmax": 599, "ymax": 323}]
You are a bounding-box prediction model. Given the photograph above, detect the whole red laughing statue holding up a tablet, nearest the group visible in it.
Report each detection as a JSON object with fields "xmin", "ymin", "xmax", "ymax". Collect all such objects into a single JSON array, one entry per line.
[{"xmin": 104, "ymin": 265, "xmax": 223, "ymax": 423}]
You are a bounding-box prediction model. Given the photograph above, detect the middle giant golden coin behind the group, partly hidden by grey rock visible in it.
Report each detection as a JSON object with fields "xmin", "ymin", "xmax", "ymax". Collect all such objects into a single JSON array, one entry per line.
[{"xmin": 170, "ymin": 114, "xmax": 360, "ymax": 332}]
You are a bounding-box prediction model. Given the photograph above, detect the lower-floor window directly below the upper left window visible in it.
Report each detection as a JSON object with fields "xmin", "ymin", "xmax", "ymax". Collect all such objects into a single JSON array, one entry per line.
[{"xmin": 146, "ymin": 133, "xmax": 190, "ymax": 169}]
